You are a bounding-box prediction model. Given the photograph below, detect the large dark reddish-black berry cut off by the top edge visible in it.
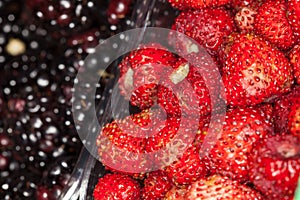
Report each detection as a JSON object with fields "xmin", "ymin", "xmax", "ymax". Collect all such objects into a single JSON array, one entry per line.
[{"xmin": 26, "ymin": 0, "xmax": 107, "ymax": 36}]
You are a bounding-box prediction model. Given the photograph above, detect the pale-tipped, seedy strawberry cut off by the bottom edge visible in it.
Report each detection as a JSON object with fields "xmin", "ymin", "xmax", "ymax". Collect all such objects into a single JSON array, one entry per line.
[{"xmin": 185, "ymin": 175, "xmax": 263, "ymax": 200}]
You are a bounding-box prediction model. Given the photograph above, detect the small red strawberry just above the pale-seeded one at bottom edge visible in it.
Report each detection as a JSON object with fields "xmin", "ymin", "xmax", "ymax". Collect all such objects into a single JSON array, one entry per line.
[{"xmin": 165, "ymin": 146, "xmax": 206, "ymax": 186}]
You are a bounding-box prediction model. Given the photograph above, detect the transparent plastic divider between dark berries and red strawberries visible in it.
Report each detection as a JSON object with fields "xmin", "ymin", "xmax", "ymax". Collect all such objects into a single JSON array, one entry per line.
[{"xmin": 59, "ymin": 0, "xmax": 156, "ymax": 200}]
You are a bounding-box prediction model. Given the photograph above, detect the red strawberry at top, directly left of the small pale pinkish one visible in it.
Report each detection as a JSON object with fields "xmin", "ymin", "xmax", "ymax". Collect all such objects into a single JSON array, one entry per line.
[{"xmin": 171, "ymin": 8, "xmax": 234, "ymax": 53}]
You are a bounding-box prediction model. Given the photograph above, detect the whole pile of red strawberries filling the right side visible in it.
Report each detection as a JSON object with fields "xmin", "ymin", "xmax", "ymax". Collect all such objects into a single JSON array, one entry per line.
[{"xmin": 93, "ymin": 0, "xmax": 300, "ymax": 200}]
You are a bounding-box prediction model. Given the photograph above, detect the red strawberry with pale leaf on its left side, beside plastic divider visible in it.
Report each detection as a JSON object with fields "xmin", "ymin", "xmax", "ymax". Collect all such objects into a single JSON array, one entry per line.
[{"xmin": 119, "ymin": 44, "xmax": 177, "ymax": 109}]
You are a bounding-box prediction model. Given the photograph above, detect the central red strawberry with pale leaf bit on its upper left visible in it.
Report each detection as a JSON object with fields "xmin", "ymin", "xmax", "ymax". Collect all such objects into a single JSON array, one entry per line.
[{"xmin": 157, "ymin": 59, "xmax": 219, "ymax": 117}]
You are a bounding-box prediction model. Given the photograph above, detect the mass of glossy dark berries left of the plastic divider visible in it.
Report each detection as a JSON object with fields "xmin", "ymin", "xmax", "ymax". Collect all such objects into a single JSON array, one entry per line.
[{"xmin": 0, "ymin": 0, "xmax": 133, "ymax": 200}]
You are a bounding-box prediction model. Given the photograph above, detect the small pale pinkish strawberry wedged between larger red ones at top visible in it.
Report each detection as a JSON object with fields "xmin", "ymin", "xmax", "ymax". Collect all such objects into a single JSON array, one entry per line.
[{"xmin": 234, "ymin": 6, "xmax": 257, "ymax": 33}]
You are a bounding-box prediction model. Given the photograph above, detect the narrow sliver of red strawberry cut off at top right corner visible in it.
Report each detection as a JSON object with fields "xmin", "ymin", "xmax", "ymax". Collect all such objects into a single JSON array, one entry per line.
[{"xmin": 287, "ymin": 0, "xmax": 300, "ymax": 40}]
